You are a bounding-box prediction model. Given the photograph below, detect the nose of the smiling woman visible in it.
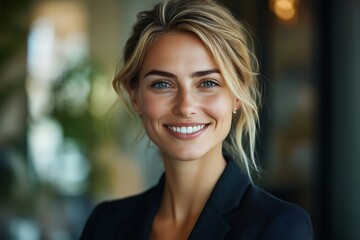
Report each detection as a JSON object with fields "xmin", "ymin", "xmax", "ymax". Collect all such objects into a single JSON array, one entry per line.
[{"xmin": 173, "ymin": 90, "xmax": 196, "ymax": 118}]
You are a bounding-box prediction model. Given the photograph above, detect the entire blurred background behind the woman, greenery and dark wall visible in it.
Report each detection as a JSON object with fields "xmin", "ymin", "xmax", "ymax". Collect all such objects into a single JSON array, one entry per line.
[{"xmin": 0, "ymin": 0, "xmax": 360, "ymax": 240}]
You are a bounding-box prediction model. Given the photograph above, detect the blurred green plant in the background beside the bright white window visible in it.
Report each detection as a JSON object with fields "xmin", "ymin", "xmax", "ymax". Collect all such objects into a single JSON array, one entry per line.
[{"xmin": 51, "ymin": 61, "xmax": 100, "ymax": 146}]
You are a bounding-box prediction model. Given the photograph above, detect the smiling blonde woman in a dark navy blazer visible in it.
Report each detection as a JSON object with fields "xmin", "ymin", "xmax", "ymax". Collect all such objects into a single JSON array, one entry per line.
[{"xmin": 81, "ymin": 0, "xmax": 312, "ymax": 240}]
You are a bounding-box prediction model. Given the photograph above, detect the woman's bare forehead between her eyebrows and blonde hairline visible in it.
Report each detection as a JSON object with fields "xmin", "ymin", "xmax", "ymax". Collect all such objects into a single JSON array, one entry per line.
[{"xmin": 140, "ymin": 32, "xmax": 217, "ymax": 72}]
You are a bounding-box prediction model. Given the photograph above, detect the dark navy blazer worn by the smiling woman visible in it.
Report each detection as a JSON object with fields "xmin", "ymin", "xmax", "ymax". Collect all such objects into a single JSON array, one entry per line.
[{"xmin": 80, "ymin": 159, "xmax": 313, "ymax": 240}]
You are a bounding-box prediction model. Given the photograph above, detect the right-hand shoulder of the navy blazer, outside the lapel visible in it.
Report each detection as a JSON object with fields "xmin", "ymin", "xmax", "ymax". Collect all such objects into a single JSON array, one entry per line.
[{"xmin": 229, "ymin": 184, "xmax": 313, "ymax": 239}]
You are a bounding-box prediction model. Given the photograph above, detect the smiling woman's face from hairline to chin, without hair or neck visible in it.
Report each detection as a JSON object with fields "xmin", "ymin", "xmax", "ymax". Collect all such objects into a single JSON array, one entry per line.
[{"xmin": 130, "ymin": 32, "xmax": 239, "ymax": 160}]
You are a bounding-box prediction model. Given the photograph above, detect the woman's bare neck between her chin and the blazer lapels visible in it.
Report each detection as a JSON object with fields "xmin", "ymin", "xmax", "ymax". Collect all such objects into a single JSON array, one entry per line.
[{"xmin": 159, "ymin": 153, "xmax": 226, "ymax": 223}]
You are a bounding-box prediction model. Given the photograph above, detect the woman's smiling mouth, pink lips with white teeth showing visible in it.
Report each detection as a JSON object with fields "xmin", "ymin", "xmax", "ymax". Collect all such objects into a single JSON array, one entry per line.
[{"xmin": 164, "ymin": 123, "xmax": 210, "ymax": 140}]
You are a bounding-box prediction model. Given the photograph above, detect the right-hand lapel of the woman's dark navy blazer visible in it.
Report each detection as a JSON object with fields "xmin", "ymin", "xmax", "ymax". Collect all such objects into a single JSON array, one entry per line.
[{"xmin": 189, "ymin": 158, "xmax": 250, "ymax": 240}]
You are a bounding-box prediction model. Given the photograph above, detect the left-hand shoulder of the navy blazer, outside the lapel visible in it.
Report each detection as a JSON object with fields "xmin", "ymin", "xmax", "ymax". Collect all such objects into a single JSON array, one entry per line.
[{"xmin": 80, "ymin": 188, "xmax": 158, "ymax": 239}]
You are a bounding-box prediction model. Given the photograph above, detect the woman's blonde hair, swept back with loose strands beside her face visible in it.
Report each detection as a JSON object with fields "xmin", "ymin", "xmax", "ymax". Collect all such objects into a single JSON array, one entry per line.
[{"xmin": 113, "ymin": 0, "xmax": 260, "ymax": 179}]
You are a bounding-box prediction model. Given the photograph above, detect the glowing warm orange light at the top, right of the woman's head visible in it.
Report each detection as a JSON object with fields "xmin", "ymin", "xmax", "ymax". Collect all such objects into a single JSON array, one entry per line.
[{"xmin": 271, "ymin": 0, "xmax": 297, "ymax": 22}]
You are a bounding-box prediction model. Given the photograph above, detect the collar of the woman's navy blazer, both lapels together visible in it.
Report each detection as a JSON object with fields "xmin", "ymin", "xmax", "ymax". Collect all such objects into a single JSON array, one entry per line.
[{"xmin": 118, "ymin": 157, "xmax": 250, "ymax": 240}]
